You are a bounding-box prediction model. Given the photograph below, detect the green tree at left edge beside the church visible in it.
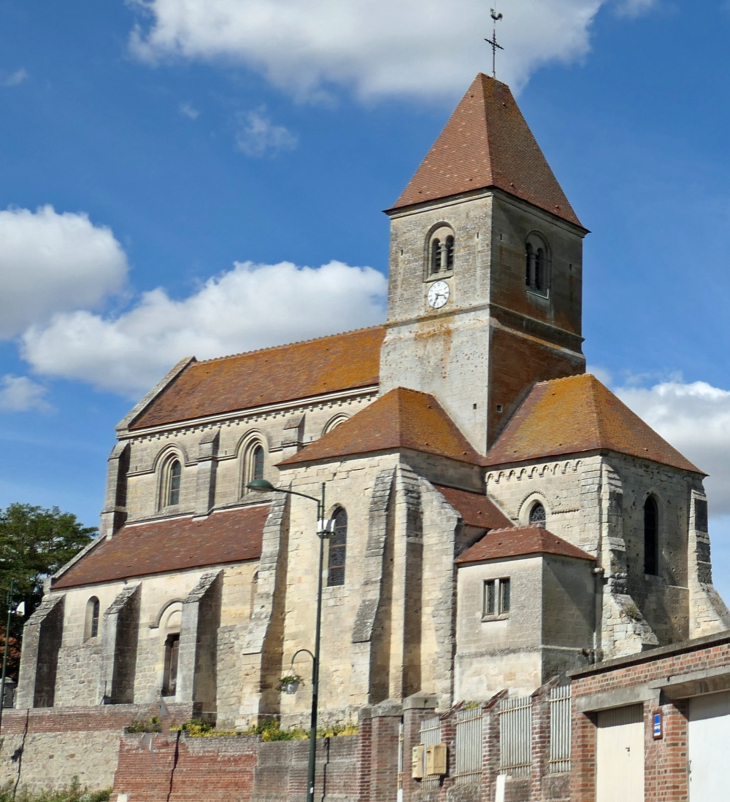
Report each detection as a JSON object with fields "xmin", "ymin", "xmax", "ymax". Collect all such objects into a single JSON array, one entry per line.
[{"xmin": 0, "ymin": 504, "xmax": 97, "ymax": 620}]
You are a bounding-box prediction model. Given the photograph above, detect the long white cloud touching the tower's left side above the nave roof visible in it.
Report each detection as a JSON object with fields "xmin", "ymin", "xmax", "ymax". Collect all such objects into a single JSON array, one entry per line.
[{"xmin": 21, "ymin": 262, "xmax": 387, "ymax": 397}]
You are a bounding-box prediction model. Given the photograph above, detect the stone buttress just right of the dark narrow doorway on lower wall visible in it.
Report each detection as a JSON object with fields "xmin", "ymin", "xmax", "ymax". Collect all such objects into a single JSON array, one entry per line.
[{"xmin": 175, "ymin": 570, "xmax": 223, "ymax": 718}]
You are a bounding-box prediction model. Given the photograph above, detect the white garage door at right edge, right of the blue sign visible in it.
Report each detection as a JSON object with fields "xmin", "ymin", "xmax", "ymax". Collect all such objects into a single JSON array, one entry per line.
[{"xmin": 688, "ymin": 693, "xmax": 730, "ymax": 802}]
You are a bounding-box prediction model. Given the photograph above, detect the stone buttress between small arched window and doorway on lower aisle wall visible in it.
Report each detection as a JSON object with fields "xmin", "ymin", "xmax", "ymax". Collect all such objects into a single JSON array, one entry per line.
[{"xmin": 99, "ymin": 585, "xmax": 142, "ymax": 704}]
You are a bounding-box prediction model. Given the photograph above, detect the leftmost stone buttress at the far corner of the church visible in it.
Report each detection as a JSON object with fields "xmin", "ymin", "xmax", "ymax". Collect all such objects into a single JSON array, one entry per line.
[{"xmin": 16, "ymin": 594, "xmax": 66, "ymax": 708}]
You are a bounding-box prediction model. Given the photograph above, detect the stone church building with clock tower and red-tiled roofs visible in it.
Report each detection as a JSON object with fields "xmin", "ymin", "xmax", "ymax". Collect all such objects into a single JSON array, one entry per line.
[{"xmin": 16, "ymin": 75, "xmax": 730, "ymax": 729}]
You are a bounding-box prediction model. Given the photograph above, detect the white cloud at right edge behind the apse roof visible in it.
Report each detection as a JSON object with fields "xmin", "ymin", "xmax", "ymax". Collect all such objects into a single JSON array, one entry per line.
[{"xmin": 614, "ymin": 381, "xmax": 730, "ymax": 516}]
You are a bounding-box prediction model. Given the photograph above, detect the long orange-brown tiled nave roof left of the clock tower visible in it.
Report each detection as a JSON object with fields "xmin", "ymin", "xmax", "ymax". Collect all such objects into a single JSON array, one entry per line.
[{"xmin": 130, "ymin": 326, "xmax": 385, "ymax": 429}]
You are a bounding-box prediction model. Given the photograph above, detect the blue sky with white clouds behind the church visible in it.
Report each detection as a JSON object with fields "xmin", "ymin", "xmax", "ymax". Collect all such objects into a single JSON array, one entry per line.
[{"xmin": 0, "ymin": 0, "xmax": 730, "ymax": 590}]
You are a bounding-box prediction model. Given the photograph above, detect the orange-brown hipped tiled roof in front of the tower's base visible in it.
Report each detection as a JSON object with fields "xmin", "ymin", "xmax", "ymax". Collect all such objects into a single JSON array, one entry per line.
[{"xmin": 279, "ymin": 387, "xmax": 482, "ymax": 467}]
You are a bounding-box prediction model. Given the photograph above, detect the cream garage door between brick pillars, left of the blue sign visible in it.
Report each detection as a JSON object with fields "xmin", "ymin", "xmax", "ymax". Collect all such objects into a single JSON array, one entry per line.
[{"xmin": 596, "ymin": 705, "xmax": 644, "ymax": 802}]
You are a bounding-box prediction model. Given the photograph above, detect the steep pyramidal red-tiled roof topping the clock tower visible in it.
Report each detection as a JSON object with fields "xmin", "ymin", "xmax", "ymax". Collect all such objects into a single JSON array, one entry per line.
[{"xmin": 386, "ymin": 73, "xmax": 581, "ymax": 226}]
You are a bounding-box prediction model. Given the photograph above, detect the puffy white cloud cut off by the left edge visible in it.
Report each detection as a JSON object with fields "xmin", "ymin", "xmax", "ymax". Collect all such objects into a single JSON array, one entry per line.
[{"xmin": 0, "ymin": 206, "xmax": 127, "ymax": 338}]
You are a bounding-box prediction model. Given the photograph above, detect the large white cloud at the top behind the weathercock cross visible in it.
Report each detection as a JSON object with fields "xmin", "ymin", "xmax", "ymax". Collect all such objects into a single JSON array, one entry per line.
[{"xmin": 130, "ymin": 0, "xmax": 649, "ymax": 99}]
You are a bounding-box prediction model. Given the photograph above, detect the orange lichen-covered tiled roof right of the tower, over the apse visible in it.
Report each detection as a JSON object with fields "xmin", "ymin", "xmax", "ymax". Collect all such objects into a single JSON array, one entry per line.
[{"xmin": 486, "ymin": 373, "xmax": 701, "ymax": 473}]
